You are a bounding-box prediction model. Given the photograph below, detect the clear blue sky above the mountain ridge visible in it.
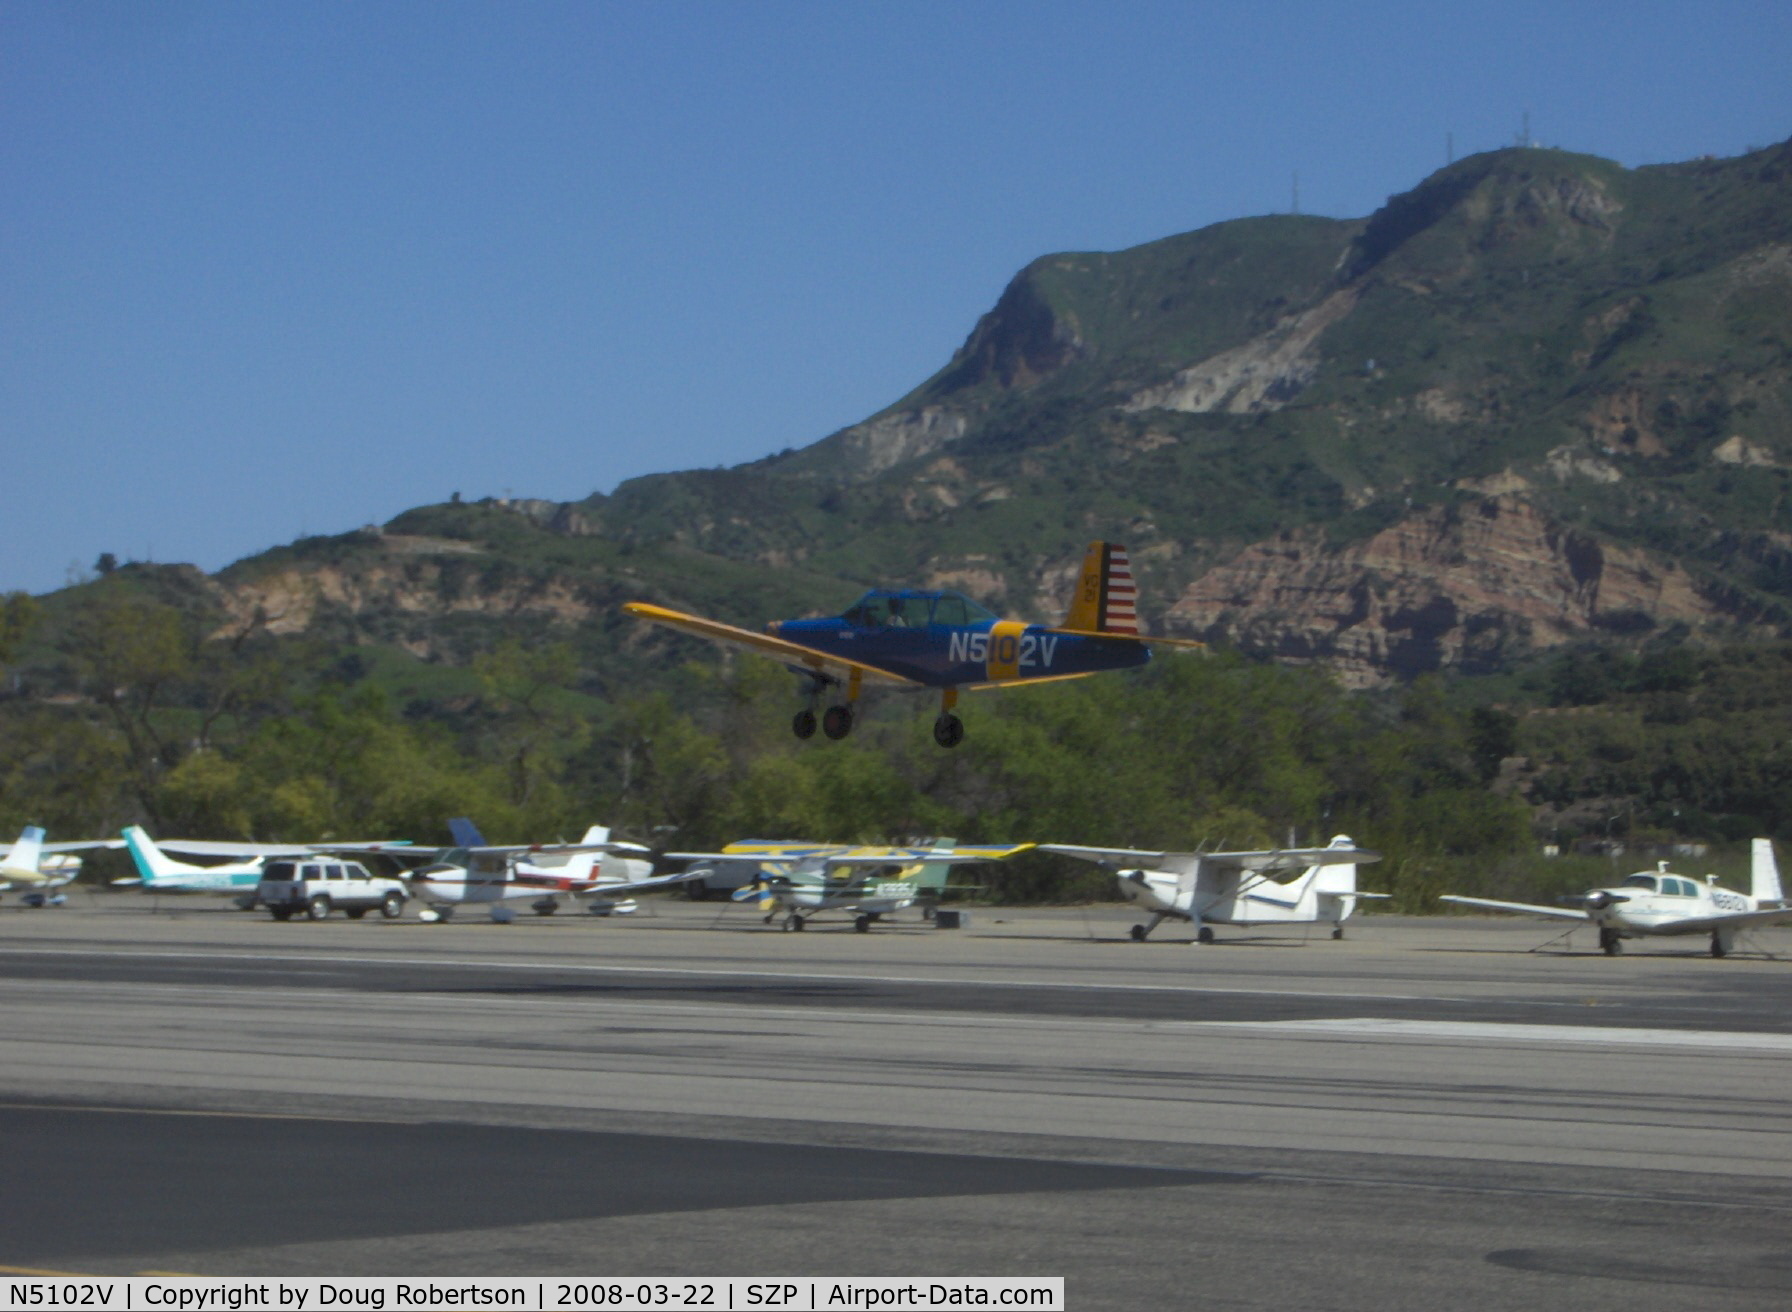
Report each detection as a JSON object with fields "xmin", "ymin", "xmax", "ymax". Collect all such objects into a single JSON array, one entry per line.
[{"xmin": 0, "ymin": 0, "xmax": 1792, "ymax": 591}]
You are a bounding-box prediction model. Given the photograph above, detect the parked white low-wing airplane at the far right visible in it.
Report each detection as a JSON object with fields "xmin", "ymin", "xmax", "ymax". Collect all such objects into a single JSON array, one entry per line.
[{"xmin": 1441, "ymin": 839, "xmax": 1792, "ymax": 957}]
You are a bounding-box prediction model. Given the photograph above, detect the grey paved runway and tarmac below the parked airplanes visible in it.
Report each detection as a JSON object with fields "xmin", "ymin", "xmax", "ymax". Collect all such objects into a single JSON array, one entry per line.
[{"xmin": 0, "ymin": 896, "xmax": 1792, "ymax": 1308}]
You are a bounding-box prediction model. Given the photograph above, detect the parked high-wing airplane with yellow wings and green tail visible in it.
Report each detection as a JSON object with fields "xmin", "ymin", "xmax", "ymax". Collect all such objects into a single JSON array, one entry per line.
[{"xmin": 667, "ymin": 839, "xmax": 1032, "ymax": 934}]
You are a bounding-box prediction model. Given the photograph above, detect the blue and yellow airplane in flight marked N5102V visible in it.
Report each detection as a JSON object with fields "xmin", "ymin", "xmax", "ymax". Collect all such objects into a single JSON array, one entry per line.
[{"xmin": 622, "ymin": 541, "xmax": 1201, "ymax": 747}]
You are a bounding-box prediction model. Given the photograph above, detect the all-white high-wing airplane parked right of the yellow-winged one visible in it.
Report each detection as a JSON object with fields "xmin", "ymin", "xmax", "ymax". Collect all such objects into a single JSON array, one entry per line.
[{"xmin": 1039, "ymin": 833, "xmax": 1387, "ymax": 943}]
